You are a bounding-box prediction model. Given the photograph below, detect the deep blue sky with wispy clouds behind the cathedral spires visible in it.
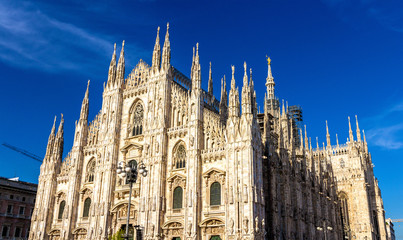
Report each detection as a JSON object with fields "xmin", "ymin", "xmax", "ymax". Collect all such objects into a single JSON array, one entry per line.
[{"xmin": 0, "ymin": 0, "xmax": 403, "ymax": 236}]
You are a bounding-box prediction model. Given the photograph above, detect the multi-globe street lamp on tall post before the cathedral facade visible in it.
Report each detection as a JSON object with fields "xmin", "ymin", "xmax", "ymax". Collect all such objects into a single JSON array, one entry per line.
[{"xmin": 116, "ymin": 160, "xmax": 148, "ymax": 239}]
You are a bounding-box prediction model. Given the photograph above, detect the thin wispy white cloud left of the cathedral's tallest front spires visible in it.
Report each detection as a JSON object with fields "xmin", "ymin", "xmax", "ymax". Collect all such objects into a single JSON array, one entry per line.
[{"xmin": 0, "ymin": 1, "xmax": 113, "ymax": 72}]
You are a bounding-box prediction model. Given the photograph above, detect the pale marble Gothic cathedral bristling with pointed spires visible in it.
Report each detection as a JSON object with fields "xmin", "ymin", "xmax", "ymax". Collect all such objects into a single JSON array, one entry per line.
[{"xmin": 29, "ymin": 26, "xmax": 386, "ymax": 240}]
